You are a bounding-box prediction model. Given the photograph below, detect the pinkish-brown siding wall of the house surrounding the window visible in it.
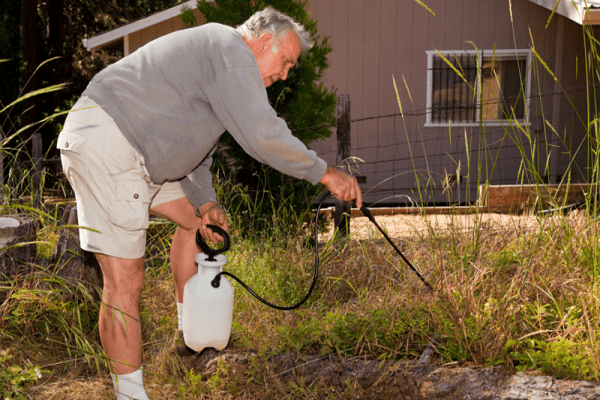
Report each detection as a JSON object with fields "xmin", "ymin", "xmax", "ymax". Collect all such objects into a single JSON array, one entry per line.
[{"xmin": 308, "ymin": 0, "xmax": 585, "ymax": 202}]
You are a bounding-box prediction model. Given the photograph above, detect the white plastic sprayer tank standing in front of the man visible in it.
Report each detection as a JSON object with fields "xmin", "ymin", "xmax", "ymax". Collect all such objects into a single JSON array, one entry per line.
[{"xmin": 183, "ymin": 253, "xmax": 233, "ymax": 352}]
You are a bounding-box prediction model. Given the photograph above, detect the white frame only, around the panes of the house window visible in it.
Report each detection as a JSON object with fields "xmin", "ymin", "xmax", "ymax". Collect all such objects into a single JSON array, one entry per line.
[{"xmin": 425, "ymin": 49, "xmax": 532, "ymax": 127}]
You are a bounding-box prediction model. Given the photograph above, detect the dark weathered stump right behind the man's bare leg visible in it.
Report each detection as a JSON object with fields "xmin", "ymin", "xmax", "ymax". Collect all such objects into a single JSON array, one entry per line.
[{"xmin": 50, "ymin": 205, "xmax": 103, "ymax": 293}]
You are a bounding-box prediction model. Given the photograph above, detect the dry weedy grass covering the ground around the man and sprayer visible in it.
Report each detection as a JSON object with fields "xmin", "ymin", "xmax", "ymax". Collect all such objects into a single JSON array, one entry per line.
[{"xmin": 0, "ymin": 206, "xmax": 600, "ymax": 399}]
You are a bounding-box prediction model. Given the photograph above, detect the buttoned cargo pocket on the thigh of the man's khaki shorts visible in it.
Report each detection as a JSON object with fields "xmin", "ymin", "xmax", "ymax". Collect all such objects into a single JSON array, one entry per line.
[{"xmin": 109, "ymin": 179, "xmax": 150, "ymax": 231}]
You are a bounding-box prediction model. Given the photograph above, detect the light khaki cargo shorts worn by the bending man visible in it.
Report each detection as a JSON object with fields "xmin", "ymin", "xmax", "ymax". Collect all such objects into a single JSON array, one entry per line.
[{"xmin": 57, "ymin": 96, "xmax": 185, "ymax": 258}]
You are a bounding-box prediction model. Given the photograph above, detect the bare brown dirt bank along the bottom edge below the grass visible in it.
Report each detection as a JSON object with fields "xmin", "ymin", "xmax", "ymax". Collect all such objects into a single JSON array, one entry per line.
[{"xmin": 187, "ymin": 351, "xmax": 600, "ymax": 400}]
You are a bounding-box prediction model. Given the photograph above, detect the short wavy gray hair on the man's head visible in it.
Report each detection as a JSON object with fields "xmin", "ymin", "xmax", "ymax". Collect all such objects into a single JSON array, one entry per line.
[{"xmin": 235, "ymin": 6, "xmax": 314, "ymax": 53}]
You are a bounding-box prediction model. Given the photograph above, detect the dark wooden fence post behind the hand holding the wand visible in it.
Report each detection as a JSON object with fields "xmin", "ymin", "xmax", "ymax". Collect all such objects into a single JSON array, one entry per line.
[{"xmin": 334, "ymin": 94, "xmax": 352, "ymax": 237}]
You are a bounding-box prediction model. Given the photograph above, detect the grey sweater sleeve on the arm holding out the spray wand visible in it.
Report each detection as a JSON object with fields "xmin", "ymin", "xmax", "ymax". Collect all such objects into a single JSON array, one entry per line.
[{"xmin": 204, "ymin": 65, "xmax": 327, "ymax": 185}]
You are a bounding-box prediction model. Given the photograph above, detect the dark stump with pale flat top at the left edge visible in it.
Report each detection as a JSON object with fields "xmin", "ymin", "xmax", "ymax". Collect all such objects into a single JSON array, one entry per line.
[{"xmin": 0, "ymin": 214, "xmax": 38, "ymax": 276}]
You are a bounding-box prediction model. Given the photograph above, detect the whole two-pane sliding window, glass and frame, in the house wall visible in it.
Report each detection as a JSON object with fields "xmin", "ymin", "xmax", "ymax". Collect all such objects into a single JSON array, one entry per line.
[{"xmin": 425, "ymin": 50, "xmax": 531, "ymax": 126}]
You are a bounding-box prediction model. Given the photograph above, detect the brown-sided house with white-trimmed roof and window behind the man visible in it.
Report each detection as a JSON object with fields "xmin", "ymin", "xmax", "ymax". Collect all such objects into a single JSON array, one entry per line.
[{"xmin": 84, "ymin": 0, "xmax": 600, "ymax": 203}]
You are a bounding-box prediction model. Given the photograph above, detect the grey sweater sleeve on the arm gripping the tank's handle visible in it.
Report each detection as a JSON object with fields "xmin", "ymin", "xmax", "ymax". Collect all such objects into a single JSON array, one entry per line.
[{"xmin": 180, "ymin": 145, "xmax": 217, "ymax": 217}]
